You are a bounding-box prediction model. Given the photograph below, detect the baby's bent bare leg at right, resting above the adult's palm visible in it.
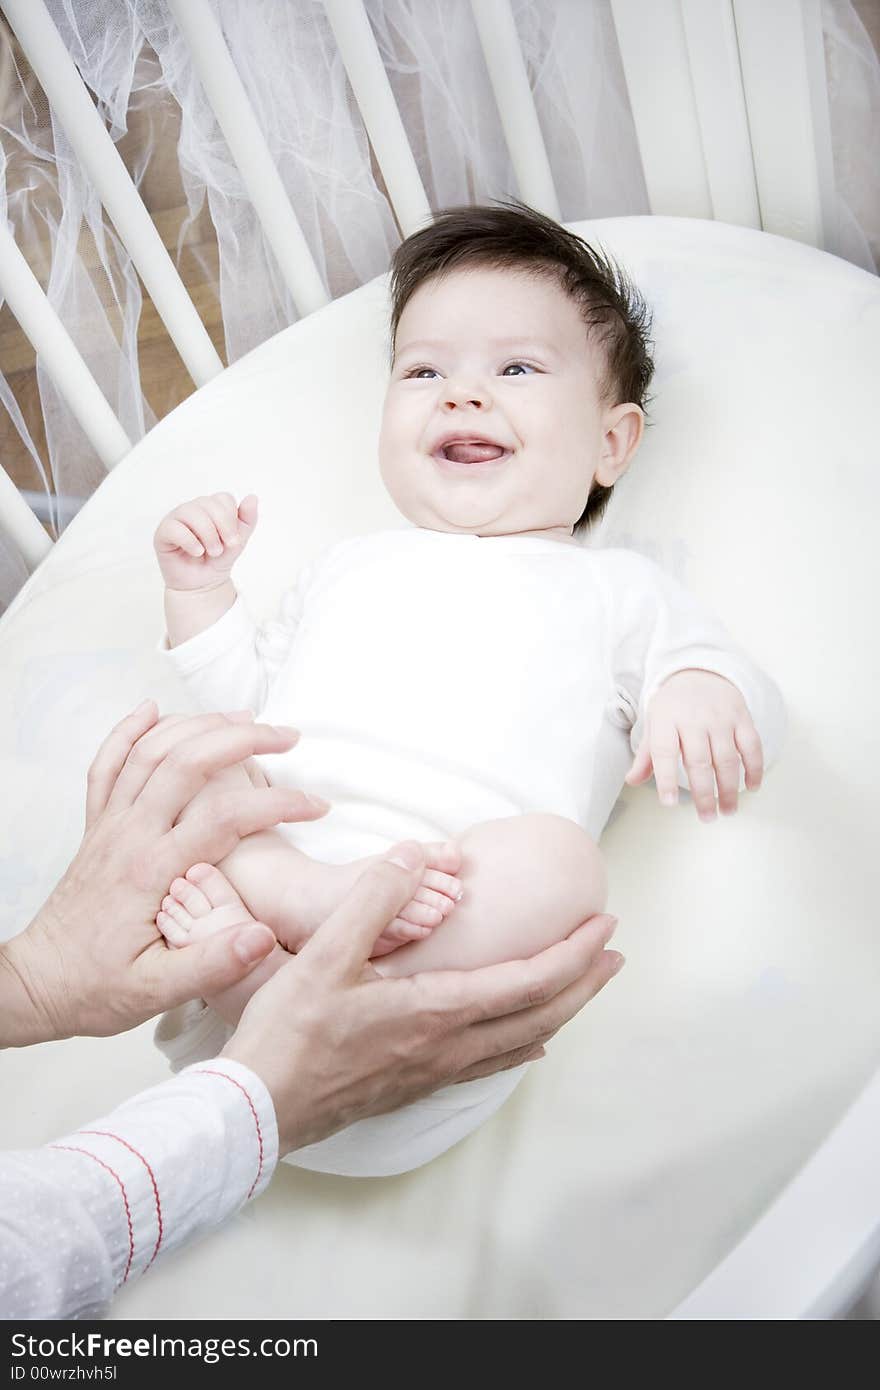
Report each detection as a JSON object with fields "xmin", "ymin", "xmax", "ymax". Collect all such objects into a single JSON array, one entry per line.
[{"xmin": 374, "ymin": 815, "xmax": 608, "ymax": 976}]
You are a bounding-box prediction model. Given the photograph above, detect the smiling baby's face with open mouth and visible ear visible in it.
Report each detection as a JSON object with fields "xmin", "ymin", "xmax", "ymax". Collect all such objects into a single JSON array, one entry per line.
[{"xmin": 380, "ymin": 267, "xmax": 642, "ymax": 539}]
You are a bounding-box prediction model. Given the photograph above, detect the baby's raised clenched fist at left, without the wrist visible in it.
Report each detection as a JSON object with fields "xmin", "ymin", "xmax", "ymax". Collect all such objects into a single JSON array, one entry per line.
[{"xmin": 153, "ymin": 492, "xmax": 257, "ymax": 591}]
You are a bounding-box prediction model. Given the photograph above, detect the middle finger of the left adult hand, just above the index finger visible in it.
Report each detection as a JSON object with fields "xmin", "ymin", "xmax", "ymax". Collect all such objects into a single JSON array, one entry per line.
[{"xmin": 123, "ymin": 716, "xmax": 299, "ymax": 830}]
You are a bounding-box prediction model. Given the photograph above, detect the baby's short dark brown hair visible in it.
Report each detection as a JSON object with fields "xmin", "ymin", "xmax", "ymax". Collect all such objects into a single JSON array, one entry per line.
[{"xmin": 391, "ymin": 199, "xmax": 653, "ymax": 531}]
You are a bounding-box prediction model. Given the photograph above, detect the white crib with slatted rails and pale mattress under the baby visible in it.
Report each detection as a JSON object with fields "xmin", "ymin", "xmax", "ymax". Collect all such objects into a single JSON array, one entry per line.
[{"xmin": 0, "ymin": 0, "xmax": 880, "ymax": 1321}]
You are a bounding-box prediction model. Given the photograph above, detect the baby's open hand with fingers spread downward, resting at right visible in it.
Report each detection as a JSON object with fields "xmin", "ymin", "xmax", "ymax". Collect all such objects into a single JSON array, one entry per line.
[{"xmin": 626, "ymin": 670, "xmax": 763, "ymax": 820}]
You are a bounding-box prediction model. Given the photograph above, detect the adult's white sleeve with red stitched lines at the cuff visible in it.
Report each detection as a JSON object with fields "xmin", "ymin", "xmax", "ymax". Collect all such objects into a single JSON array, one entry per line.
[{"xmin": 0, "ymin": 1058, "xmax": 278, "ymax": 1319}]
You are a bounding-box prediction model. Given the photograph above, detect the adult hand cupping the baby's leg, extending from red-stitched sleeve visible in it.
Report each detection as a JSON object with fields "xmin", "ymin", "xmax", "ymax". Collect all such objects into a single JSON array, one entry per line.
[{"xmin": 226, "ymin": 842, "xmax": 623, "ymax": 1154}]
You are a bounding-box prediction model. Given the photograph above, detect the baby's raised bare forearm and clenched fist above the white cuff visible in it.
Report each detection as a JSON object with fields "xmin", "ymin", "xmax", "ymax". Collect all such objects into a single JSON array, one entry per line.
[{"xmin": 153, "ymin": 492, "xmax": 257, "ymax": 648}]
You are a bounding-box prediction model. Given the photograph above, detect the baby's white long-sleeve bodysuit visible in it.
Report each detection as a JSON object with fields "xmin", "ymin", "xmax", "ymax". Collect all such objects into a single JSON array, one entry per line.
[{"xmin": 156, "ymin": 530, "xmax": 785, "ymax": 1175}]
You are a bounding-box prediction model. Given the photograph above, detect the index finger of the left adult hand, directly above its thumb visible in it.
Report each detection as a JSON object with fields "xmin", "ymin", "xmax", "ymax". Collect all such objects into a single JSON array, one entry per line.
[{"xmin": 157, "ymin": 787, "xmax": 329, "ymax": 884}]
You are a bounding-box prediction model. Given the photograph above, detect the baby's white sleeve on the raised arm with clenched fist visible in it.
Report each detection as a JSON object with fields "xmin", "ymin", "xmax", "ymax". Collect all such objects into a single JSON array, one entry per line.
[{"xmin": 160, "ymin": 571, "xmax": 309, "ymax": 714}]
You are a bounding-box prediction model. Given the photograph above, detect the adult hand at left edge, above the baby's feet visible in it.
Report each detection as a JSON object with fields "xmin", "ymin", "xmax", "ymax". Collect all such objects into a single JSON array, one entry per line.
[{"xmin": 0, "ymin": 701, "xmax": 327, "ymax": 1045}]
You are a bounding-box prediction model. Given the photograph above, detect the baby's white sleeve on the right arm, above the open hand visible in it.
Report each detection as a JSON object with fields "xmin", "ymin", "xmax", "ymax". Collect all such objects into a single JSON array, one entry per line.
[{"xmin": 596, "ymin": 550, "xmax": 787, "ymax": 791}]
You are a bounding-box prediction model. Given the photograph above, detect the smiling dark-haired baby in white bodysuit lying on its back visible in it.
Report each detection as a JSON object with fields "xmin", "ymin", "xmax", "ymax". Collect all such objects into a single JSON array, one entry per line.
[{"xmin": 154, "ymin": 204, "xmax": 784, "ymax": 1175}]
